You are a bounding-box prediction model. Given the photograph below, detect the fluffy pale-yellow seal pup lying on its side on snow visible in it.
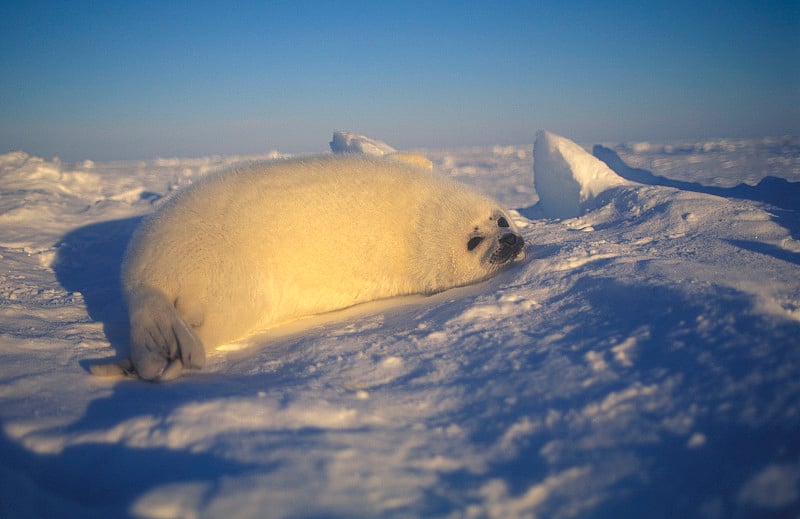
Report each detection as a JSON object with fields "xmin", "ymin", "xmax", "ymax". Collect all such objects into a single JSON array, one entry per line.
[{"xmin": 122, "ymin": 154, "xmax": 524, "ymax": 381}]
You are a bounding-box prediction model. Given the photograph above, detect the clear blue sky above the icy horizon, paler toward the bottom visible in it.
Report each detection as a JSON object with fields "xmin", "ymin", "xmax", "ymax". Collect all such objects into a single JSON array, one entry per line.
[{"xmin": 0, "ymin": 0, "xmax": 800, "ymax": 160}]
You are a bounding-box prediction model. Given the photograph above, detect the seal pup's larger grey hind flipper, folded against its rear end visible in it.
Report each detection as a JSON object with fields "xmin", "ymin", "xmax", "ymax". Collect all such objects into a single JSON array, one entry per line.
[{"xmin": 128, "ymin": 289, "xmax": 206, "ymax": 381}]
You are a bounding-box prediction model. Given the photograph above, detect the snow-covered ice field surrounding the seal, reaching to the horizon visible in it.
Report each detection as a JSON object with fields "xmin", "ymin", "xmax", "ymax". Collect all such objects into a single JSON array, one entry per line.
[{"xmin": 0, "ymin": 133, "xmax": 800, "ymax": 518}]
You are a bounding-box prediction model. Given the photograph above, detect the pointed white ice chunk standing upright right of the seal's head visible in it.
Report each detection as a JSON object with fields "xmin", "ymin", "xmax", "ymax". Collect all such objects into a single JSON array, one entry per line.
[{"xmin": 533, "ymin": 131, "xmax": 634, "ymax": 218}]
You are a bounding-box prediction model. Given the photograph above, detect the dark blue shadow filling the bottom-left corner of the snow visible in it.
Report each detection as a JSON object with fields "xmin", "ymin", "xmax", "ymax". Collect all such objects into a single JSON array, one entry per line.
[{"xmin": 0, "ymin": 422, "xmax": 260, "ymax": 518}]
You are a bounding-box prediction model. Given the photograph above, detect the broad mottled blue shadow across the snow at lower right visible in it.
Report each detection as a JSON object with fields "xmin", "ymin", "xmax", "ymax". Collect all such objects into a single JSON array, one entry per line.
[{"xmin": 429, "ymin": 276, "xmax": 800, "ymax": 519}]
